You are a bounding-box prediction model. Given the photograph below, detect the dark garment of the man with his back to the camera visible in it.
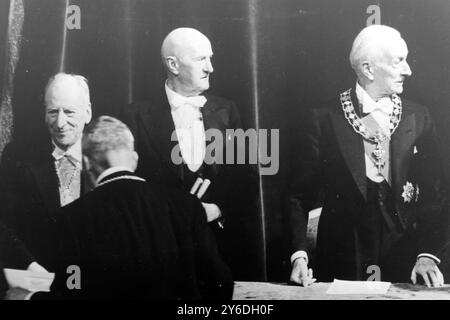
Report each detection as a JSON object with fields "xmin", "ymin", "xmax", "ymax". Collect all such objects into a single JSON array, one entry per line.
[{"xmin": 41, "ymin": 171, "xmax": 233, "ymax": 299}]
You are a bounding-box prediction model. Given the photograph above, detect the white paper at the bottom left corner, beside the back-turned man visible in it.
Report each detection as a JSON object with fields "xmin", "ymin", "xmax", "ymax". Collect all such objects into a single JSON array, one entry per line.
[{"xmin": 3, "ymin": 268, "xmax": 55, "ymax": 292}]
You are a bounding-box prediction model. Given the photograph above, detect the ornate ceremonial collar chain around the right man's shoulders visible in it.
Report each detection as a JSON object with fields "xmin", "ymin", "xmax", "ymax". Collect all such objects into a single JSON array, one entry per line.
[{"xmin": 340, "ymin": 88, "xmax": 402, "ymax": 144}]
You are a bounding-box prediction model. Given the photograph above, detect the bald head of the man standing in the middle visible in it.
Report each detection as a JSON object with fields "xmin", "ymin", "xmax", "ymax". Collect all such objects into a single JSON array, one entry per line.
[{"xmin": 161, "ymin": 28, "xmax": 214, "ymax": 96}]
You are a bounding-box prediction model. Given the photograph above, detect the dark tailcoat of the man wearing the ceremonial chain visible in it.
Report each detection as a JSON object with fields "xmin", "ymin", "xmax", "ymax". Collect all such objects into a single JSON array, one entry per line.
[{"xmin": 288, "ymin": 92, "xmax": 446, "ymax": 281}]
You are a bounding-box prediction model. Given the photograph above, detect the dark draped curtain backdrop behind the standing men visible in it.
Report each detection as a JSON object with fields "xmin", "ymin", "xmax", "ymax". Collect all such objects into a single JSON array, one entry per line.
[{"xmin": 0, "ymin": 0, "xmax": 450, "ymax": 281}]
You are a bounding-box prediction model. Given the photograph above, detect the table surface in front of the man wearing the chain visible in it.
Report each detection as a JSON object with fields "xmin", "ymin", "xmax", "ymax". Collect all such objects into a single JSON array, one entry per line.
[{"xmin": 233, "ymin": 281, "xmax": 450, "ymax": 300}]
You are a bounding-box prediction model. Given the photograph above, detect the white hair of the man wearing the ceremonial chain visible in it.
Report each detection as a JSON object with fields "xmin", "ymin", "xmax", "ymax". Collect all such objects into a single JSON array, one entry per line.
[{"xmin": 349, "ymin": 25, "xmax": 402, "ymax": 75}]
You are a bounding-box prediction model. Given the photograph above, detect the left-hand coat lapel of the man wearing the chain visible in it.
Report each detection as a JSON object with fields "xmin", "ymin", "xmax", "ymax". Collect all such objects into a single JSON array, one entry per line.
[{"xmin": 331, "ymin": 91, "xmax": 367, "ymax": 199}]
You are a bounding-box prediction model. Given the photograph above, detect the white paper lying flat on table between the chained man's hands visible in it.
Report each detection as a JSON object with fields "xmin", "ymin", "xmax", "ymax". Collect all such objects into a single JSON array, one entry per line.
[{"xmin": 327, "ymin": 279, "xmax": 391, "ymax": 294}]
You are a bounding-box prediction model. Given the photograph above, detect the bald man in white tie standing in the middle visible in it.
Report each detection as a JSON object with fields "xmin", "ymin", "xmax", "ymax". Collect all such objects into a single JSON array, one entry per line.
[{"xmin": 122, "ymin": 28, "xmax": 258, "ymax": 278}]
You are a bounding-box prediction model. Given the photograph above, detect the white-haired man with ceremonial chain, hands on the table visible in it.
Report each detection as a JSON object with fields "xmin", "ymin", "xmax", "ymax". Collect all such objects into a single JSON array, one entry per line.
[{"xmin": 289, "ymin": 25, "xmax": 445, "ymax": 286}]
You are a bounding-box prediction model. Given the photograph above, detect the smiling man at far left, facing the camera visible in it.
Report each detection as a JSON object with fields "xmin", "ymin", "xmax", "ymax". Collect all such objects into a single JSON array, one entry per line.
[{"xmin": 0, "ymin": 73, "xmax": 91, "ymax": 266}]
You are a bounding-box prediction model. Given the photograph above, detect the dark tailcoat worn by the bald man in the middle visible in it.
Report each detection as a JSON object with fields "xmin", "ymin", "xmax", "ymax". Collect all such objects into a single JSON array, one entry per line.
[{"xmin": 120, "ymin": 87, "xmax": 261, "ymax": 279}]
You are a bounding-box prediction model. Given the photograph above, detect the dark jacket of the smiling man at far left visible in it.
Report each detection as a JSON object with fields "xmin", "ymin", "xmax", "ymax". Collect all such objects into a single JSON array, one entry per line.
[{"xmin": 0, "ymin": 139, "xmax": 89, "ymax": 267}]
